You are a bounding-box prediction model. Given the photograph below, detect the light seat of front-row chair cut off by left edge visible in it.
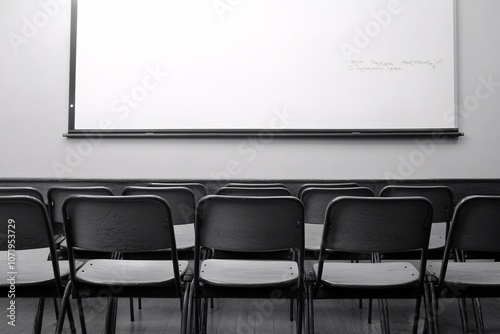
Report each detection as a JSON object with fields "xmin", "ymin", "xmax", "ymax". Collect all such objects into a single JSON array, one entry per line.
[{"xmin": 0, "ymin": 261, "xmax": 69, "ymax": 286}]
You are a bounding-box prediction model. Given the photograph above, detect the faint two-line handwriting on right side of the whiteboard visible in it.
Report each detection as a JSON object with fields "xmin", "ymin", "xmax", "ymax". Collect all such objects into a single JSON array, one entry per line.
[{"xmin": 347, "ymin": 58, "xmax": 443, "ymax": 73}]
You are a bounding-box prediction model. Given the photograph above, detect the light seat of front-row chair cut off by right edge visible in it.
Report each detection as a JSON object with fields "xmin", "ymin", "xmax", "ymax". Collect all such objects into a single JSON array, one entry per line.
[{"xmin": 427, "ymin": 262, "xmax": 500, "ymax": 287}]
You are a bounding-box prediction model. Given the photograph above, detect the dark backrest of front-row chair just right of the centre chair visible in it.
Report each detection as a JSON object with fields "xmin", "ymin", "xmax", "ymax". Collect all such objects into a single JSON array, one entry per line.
[{"xmin": 320, "ymin": 197, "xmax": 432, "ymax": 253}]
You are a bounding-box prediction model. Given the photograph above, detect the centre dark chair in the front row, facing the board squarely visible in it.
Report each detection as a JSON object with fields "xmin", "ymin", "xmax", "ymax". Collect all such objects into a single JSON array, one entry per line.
[{"xmin": 190, "ymin": 195, "xmax": 304, "ymax": 333}]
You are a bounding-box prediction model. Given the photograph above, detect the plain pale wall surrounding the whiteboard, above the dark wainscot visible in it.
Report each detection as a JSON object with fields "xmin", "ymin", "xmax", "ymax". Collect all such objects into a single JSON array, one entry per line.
[{"xmin": 0, "ymin": 0, "xmax": 500, "ymax": 179}]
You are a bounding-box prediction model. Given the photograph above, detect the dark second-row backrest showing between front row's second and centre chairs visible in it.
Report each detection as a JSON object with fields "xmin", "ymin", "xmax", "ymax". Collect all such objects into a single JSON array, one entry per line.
[{"xmin": 122, "ymin": 186, "xmax": 196, "ymax": 225}]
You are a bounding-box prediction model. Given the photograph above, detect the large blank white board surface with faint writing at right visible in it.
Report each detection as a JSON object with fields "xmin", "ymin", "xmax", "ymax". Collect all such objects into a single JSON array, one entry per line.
[{"xmin": 69, "ymin": 0, "xmax": 457, "ymax": 131}]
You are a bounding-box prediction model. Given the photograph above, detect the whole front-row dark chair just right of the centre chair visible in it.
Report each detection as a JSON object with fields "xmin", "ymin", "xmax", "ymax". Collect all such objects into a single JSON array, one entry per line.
[{"xmin": 307, "ymin": 197, "xmax": 432, "ymax": 333}]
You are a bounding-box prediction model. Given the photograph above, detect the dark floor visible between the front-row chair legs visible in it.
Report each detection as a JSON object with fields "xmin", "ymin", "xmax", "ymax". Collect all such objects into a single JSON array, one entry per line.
[{"xmin": 0, "ymin": 298, "xmax": 500, "ymax": 334}]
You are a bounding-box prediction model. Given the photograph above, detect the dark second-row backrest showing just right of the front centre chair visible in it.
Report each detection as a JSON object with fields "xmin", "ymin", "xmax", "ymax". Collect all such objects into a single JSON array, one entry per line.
[{"xmin": 300, "ymin": 187, "xmax": 373, "ymax": 224}]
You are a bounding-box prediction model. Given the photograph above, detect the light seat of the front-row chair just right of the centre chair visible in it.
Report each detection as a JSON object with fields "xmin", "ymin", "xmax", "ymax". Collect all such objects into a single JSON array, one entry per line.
[{"xmin": 313, "ymin": 262, "xmax": 419, "ymax": 288}]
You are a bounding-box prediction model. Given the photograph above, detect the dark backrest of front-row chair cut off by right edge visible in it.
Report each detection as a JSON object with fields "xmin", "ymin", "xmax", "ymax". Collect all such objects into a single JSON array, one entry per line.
[{"xmin": 445, "ymin": 195, "xmax": 500, "ymax": 254}]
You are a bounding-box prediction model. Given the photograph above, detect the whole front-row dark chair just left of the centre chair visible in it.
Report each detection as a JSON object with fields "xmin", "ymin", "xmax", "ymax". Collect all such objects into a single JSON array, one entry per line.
[{"xmin": 57, "ymin": 195, "xmax": 189, "ymax": 333}]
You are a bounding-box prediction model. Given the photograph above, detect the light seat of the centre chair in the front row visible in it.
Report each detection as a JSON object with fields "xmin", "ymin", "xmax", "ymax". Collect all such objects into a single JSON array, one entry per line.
[{"xmin": 200, "ymin": 259, "xmax": 299, "ymax": 288}]
